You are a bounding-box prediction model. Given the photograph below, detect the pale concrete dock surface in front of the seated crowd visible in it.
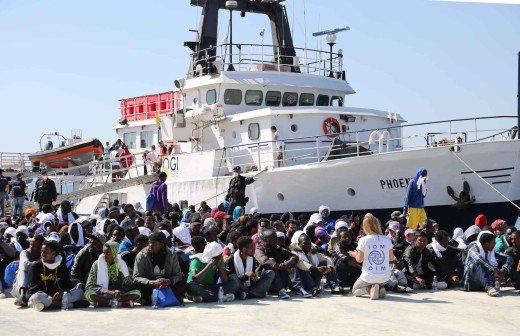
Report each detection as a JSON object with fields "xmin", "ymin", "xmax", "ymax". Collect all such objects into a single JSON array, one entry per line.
[{"xmin": 0, "ymin": 288, "xmax": 520, "ymax": 336}]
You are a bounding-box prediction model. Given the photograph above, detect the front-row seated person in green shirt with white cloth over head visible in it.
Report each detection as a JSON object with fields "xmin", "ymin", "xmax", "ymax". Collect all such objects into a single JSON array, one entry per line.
[{"xmin": 188, "ymin": 237, "xmax": 242, "ymax": 302}]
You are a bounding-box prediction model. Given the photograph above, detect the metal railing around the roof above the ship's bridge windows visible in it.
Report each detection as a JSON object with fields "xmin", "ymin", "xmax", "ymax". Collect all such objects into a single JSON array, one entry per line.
[{"xmin": 188, "ymin": 43, "xmax": 345, "ymax": 79}]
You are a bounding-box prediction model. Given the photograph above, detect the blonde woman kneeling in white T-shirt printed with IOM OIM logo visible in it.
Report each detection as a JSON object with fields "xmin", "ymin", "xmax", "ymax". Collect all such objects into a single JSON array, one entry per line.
[{"xmin": 349, "ymin": 214, "xmax": 395, "ymax": 300}]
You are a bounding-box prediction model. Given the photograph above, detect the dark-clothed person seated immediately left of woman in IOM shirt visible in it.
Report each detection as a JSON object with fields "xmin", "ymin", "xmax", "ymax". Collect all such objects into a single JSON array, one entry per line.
[{"xmin": 332, "ymin": 228, "xmax": 361, "ymax": 292}]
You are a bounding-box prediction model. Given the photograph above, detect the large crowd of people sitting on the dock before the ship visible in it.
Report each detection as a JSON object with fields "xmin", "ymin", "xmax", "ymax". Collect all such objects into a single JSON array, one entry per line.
[{"xmin": 0, "ymin": 169, "xmax": 520, "ymax": 311}]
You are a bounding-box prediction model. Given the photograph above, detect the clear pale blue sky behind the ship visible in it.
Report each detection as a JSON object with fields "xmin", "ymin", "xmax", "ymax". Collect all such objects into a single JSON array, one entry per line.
[{"xmin": 0, "ymin": 0, "xmax": 520, "ymax": 152}]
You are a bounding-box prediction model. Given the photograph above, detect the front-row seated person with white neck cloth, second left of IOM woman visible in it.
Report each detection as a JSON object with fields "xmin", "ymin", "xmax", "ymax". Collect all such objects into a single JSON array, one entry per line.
[{"xmin": 291, "ymin": 234, "xmax": 340, "ymax": 296}]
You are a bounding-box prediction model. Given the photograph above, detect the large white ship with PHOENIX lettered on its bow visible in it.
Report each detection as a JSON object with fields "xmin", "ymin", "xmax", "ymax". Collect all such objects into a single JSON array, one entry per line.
[{"xmin": 69, "ymin": 0, "xmax": 520, "ymax": 228}]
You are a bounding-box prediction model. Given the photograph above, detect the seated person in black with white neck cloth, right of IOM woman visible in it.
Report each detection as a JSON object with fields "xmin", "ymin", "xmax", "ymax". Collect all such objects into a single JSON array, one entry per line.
[{"xmin": 426, "ymin": 230, "xmax": 463, "ymax": 289}]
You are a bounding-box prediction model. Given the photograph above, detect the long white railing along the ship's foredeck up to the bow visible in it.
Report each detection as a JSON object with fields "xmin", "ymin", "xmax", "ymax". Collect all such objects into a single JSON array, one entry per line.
[{"xmin": 210, "ymin": 116, "xmax": 518, "ymax": 175}]
